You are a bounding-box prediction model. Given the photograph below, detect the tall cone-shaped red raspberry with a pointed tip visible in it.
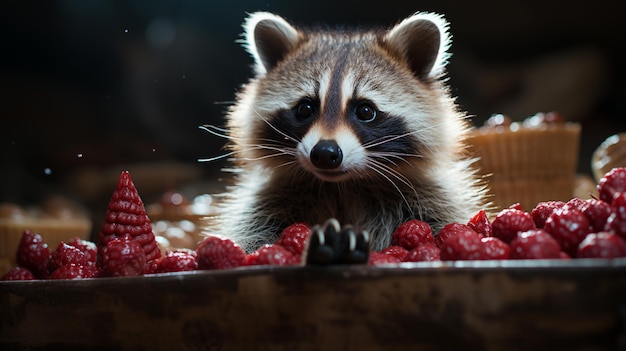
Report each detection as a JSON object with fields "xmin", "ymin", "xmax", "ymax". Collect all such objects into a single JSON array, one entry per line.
[{"xmin": 98, "ymin": 171, "xmax": 161, "ymax": 261}]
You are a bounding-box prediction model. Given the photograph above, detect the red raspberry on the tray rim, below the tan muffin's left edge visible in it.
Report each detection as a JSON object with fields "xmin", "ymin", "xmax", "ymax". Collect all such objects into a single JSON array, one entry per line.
[{"xmin": 439, "ymin": 224, "xmax": 482, "ymax": 261}]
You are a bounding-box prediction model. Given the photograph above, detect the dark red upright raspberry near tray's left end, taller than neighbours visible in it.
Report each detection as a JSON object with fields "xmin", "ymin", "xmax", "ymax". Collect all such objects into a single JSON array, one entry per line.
[{"xmin": 16, "ymin": 229, "xmax": 50, "ymax": 278}]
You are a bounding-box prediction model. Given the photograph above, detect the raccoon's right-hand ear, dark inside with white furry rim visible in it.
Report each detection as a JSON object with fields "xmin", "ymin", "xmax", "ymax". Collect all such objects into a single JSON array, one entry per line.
[{"xmin": 384, "ymin": 13, "xmax": 450, "ymax": 79}]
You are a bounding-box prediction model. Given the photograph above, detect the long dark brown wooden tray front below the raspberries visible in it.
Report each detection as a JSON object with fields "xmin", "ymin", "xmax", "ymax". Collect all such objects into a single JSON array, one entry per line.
[{"xmin": 0, "ymin": 259, "xmax": 626, "ymax": 350}]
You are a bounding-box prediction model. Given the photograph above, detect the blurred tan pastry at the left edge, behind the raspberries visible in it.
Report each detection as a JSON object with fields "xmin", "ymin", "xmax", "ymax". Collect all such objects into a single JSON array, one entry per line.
[{"xmin": 0, "ymin": 196, "xmax": 92, "ymax": 274}]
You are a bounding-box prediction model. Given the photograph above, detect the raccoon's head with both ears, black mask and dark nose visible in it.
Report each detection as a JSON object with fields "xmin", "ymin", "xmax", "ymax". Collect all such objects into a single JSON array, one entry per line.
[{"xmin": 238, "ymin": 13, "xmax": 454, "ymax": 182}]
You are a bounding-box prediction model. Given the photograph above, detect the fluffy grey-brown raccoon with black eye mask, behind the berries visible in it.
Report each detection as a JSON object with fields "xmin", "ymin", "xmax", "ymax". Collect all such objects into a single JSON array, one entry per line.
[{"xmin": 209, "ymin": 12, "xmax": 486, "ymax": 252}]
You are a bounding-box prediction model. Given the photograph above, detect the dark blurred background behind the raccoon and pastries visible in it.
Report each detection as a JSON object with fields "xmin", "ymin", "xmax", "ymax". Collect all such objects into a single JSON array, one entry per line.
[{"xmin": 0, "ymin": 0, "xmax": 626, "ymax": 214}]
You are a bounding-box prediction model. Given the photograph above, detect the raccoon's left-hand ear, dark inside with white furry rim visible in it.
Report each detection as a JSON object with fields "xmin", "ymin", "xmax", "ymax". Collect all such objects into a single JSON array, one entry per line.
[{"xmin": 243, "ymin": 12, "xmax": 300, "ymax": 73}]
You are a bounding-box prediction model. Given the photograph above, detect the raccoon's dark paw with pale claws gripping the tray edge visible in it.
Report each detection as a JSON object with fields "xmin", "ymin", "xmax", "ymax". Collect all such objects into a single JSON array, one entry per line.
[{"xmin": 305, "ymin": 219, "xmax": 369, "ymax": 265}]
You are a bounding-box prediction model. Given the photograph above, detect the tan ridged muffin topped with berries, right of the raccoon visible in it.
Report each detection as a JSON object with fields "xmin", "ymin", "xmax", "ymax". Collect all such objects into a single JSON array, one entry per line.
[{"xmin": 467, "ymin": 112, "xmax": 580, "ymax": 209}]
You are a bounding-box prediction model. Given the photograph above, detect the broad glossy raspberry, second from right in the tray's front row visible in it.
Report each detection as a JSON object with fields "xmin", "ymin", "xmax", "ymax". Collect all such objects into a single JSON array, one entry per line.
[{"xmin": 511, "ymin": 229, "xmax": 561, "ymax": 259}]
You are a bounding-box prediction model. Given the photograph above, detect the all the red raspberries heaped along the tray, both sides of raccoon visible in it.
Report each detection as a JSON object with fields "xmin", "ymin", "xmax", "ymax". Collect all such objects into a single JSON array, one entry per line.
[{"xmin": 0, "ymin": 168, "xmax": 626, "ymax": 281}]
